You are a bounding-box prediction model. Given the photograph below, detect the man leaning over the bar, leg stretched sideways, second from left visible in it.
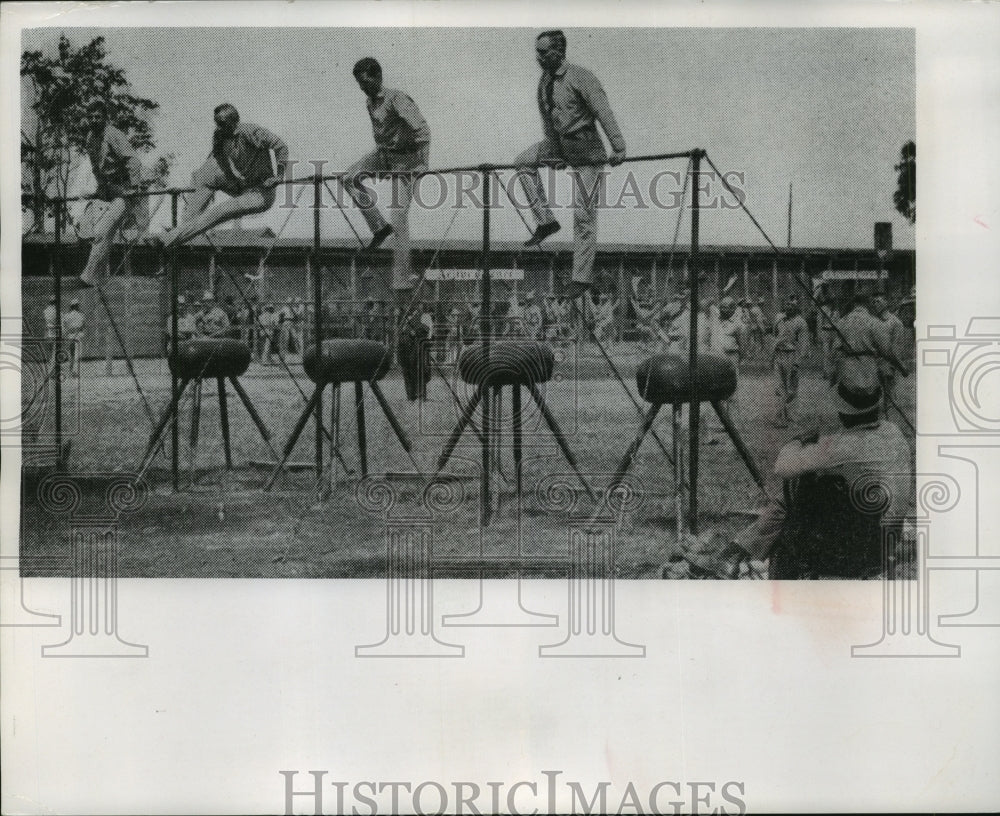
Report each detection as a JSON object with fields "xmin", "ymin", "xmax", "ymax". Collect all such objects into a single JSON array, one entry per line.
[{"xmin": 156, "ymin": 102, "xmax": 288, "ymax": 247}]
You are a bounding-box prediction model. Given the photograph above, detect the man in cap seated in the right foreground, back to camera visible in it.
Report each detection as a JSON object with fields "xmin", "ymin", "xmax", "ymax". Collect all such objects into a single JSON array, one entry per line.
[{"xmin": 718, "ymin": 374, "xmax": 913, "ymax": 577}]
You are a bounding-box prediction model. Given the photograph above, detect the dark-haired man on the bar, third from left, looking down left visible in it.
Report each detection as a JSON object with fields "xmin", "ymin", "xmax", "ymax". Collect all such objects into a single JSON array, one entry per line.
[{"xmin": 344, "ymin": 57, "xmax": 431, "ymax": 292}]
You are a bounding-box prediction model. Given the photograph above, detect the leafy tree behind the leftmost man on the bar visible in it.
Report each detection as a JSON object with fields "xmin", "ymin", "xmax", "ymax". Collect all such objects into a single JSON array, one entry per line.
[{"xmin": 21, "ymin": 35, "xmax": 173, "ymax": 232}]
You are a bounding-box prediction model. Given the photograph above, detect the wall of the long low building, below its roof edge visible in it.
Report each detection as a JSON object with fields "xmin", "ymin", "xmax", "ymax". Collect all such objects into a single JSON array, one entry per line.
[{"xmin": 22, "ymin": 241, "xmax": 914, "ymax": 357}]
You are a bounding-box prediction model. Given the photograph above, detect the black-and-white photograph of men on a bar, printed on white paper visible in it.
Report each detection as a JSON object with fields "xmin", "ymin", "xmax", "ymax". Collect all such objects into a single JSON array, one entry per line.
[{"xmin": 15, "ymin": 28, "xmax": 916, "ymax": 580}]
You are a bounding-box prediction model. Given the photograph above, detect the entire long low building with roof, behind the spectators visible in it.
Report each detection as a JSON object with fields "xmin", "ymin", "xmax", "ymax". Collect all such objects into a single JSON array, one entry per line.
[{"xmin": 21, "ymin": 229, "xmax": 915, "ymax": 357}]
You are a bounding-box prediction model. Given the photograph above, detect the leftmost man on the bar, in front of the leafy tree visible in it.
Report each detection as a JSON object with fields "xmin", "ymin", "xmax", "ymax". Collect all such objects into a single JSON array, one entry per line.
[{"xmin": 80, "ymin": 100, "xmax": 146, "ymax": 286}]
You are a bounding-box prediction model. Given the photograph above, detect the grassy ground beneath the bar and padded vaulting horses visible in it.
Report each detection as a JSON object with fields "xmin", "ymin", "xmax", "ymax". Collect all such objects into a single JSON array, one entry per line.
[{"xmin": 22, "ymin": 346, "xmax": 914, "ymax": 578}]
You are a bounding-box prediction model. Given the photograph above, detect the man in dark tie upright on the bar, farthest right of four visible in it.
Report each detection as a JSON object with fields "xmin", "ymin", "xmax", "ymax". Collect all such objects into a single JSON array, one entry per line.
[{"xmin": 514, "ymin": 31, "xmax": 625, "ymax": 299}]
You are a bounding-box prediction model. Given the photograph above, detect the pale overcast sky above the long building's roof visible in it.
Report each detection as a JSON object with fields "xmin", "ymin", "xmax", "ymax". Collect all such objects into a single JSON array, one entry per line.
[{"xmin": 24, "ymin": 28, "xmax": 915, "ymax": 247}]
